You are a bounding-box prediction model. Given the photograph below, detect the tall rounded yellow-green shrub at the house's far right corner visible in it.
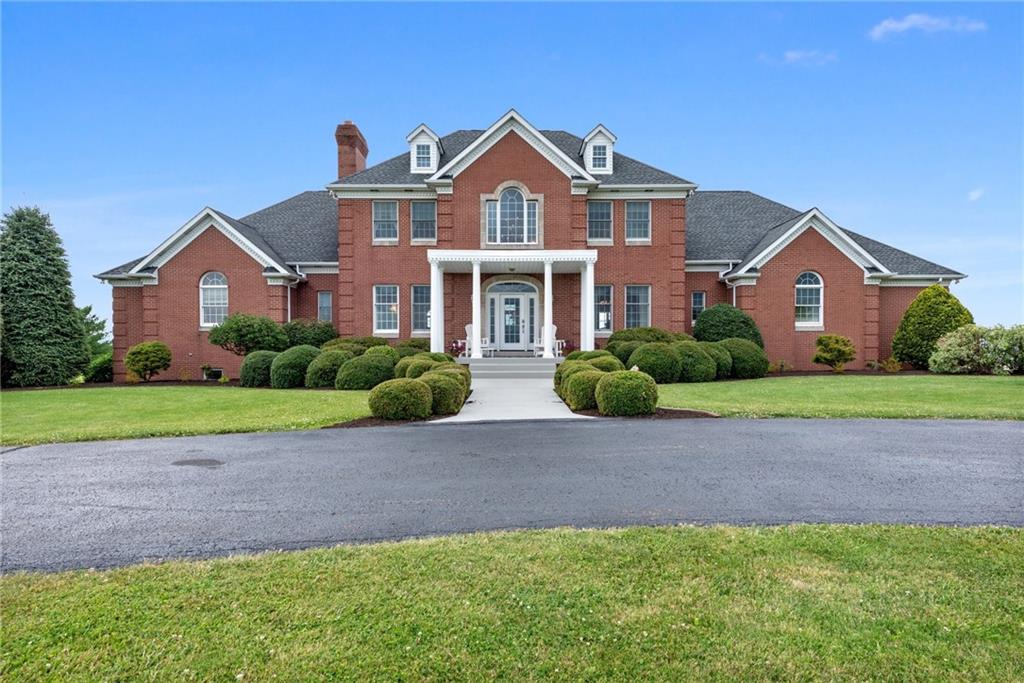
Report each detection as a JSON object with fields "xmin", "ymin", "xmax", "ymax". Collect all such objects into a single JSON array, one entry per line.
[{"xmin": 893, "ymin": 285, "xmax": 974, "ymax": 370}]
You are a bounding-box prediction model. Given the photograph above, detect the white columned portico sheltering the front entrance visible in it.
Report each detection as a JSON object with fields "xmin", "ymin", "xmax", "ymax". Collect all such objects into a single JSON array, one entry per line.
[{"xmin": 427, "ymin": 249, "xmax": 597, "ymax": 358}]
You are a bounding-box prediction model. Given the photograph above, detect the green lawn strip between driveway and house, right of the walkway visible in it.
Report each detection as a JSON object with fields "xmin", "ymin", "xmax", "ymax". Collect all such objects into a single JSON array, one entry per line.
[{"xmin": 658, "ymin": 375, "xmax": 1024, "ymax": 420}]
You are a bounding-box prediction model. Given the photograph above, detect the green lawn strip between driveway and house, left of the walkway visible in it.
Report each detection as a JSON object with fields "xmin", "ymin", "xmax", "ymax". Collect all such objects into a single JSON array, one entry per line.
[{"xmin": 0, "ymin": 386, "xmax": 370, "ymax": 445}]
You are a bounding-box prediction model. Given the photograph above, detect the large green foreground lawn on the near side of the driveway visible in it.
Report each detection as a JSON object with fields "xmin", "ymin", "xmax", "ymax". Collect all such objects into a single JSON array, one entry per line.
[{"xmin": 0, "ymin": 525, "xmax": 1024, "ymax": 681}]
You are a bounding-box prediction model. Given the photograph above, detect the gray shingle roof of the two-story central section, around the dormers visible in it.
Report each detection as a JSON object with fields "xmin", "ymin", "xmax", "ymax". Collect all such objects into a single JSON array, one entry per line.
[{"xmin": 336, "ymin": 130, "xmax": 692, "ymax": 185}]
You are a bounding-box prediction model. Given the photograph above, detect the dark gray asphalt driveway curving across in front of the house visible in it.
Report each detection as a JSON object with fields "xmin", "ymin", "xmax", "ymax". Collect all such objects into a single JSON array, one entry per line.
[{"xmin": 0, "ymin": 420, "xmax": 1024, "ymax": 571}]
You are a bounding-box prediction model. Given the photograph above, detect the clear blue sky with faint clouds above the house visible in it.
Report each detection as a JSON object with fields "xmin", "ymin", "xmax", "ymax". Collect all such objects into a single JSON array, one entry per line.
[{"xmin": 0, "ymin": 3, "xmax": 1024, "ymax": 324}]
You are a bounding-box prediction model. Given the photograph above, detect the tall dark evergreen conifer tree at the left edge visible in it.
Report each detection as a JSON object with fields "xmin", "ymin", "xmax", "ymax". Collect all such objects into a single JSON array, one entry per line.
[{"xmin": 0, "ymin": 207, "xmax": 89, "ymax": 386}]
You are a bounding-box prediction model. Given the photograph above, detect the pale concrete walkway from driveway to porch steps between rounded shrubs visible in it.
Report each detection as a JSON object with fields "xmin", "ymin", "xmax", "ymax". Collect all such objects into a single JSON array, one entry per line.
[{"xmin": 434, "ymin": 377, "xmax": 592, "ymax": 425}]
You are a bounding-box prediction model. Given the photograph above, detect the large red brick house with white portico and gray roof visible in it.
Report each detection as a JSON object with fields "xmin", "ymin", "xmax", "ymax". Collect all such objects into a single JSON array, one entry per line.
[{"xmin": 96, "ymin": 111, "xmax": 965, "ymax": 380}]
